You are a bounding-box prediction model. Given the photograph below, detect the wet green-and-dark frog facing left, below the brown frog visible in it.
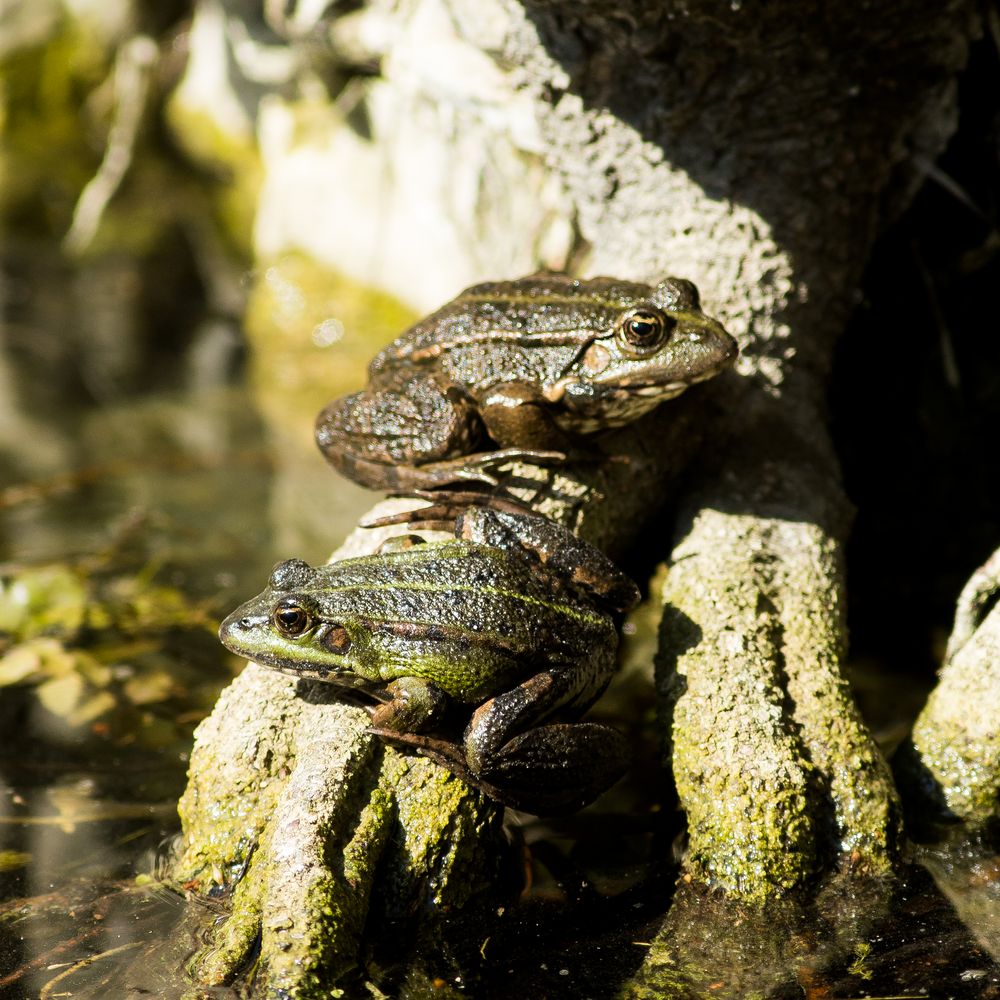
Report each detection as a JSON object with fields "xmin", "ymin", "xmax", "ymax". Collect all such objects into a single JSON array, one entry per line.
[{"xmin": 219, "ymin": 507, "xmax": 638, "ymax": 812}]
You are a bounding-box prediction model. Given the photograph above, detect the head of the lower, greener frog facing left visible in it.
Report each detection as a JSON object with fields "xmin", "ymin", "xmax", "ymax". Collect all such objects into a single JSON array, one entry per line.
[{"xmin": 219, "ymin": 559, "xmax": 370, "ymax": 687}]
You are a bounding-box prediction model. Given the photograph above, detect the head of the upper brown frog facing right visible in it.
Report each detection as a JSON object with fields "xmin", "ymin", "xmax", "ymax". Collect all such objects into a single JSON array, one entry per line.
[{"xmin": 551, "ymin": 278, "xmax": 738, "ymax": 430}]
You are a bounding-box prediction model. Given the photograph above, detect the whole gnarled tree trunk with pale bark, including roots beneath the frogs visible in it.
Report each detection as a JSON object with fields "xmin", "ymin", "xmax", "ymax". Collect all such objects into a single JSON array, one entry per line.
[{"xmin": 175, "ymin": 0, "xmax": 975, "ymax": 996}]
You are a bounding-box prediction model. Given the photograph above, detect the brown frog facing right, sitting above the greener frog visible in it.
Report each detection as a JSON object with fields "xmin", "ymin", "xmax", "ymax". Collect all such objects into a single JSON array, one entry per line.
[{"xmin": 316, "ymin": 273, "xmax": 737, "ymax": 490}]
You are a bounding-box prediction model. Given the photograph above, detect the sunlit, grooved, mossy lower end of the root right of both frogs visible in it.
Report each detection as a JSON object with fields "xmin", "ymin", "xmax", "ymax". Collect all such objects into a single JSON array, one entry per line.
[{"xmin": 657, "ymin": 510, "xmax": 899, "ymax": 903}]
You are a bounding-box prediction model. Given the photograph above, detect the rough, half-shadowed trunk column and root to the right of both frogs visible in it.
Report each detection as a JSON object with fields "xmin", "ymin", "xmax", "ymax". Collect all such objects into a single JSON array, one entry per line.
[{"xmin": 500, "ymin": 3, "xmax": 971, "ymax": 898}]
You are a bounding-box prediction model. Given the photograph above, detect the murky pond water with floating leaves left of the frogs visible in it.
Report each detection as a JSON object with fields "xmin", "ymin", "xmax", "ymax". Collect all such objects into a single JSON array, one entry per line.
[{"xmin": 0, "ymin": 232, "xmax": 370, "ymax": 997}]
